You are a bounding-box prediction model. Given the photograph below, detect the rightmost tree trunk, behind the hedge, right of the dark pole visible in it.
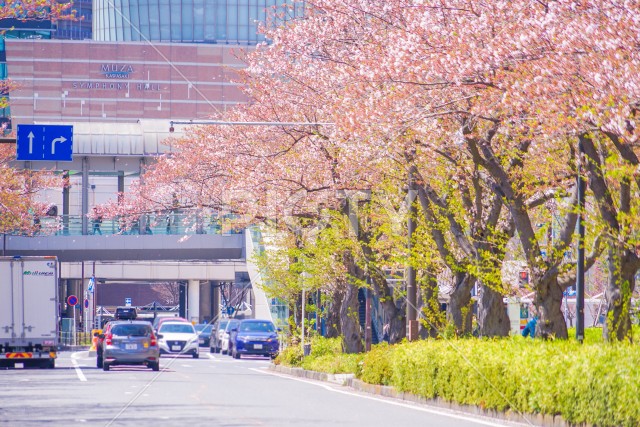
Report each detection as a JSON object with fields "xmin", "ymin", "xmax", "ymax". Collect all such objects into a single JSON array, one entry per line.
[{"xmin": 603, "ymin": 247, "xmax": 638, "ymax": 341}]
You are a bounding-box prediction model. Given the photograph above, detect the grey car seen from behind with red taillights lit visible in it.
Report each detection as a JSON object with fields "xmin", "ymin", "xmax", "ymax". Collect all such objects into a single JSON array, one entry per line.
[{"xmin": 98, "ymin": 320, "xmax": 160, "ymax": 371}]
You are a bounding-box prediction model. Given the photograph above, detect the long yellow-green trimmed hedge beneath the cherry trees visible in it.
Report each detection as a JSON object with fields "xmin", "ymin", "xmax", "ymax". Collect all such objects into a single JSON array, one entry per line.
[{"xmin": 357, "ymin": 337, "xmax": 640, "ymax": 426}]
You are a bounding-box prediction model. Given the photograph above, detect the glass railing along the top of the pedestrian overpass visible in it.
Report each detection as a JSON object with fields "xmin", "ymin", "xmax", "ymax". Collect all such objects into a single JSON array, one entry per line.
[{"xmin": 13, "ymin": 212, "xmax": 244, "ymax": 236}]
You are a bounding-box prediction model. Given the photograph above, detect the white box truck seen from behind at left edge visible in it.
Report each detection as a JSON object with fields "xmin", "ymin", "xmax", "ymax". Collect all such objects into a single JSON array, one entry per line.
[{"xmin": 0, "ymin": 256, "xmax": 58, "ymax": 368}]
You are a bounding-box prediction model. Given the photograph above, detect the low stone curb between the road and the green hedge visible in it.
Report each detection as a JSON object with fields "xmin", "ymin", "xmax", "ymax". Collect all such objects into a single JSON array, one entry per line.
[{"xmin": 269, "ymin": 364, "xmax": 576, "ymax": 427}]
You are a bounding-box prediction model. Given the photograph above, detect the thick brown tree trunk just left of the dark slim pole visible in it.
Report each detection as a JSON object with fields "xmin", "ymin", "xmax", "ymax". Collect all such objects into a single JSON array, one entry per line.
[{"xmin": 535, "ymin": 275, "xmax": 569, "ymax": 339}]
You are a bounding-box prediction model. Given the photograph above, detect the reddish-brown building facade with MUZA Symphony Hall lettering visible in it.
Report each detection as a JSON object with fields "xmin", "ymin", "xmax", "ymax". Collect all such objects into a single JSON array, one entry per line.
[{"xmin": 5, "ymin": 39, "xmax": 246, "ymax": 126}]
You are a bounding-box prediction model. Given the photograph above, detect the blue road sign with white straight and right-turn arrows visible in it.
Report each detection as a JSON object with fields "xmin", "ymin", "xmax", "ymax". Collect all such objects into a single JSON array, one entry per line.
[{"xmin": 16, "ymin": 125, "xmax": 73, "ymax": 162}]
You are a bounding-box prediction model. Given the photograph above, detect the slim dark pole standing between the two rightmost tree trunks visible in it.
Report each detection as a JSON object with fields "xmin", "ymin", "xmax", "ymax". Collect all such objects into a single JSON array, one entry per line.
[{"xmin": 576, "ymin": 138, "xmax": 586, "ymax": 343}]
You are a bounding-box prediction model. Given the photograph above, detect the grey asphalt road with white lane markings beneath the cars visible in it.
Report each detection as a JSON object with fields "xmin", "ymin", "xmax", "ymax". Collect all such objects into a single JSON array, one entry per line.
[{"xmin": 0, "ymin": 351, "xmax": 528, "ymax": 427}]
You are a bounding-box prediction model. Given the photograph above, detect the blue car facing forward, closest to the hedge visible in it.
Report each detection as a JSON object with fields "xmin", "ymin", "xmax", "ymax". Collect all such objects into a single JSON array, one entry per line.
[{"xmin": 229, "ymin": 319, "xmax": 280, "ymax": 359}]
